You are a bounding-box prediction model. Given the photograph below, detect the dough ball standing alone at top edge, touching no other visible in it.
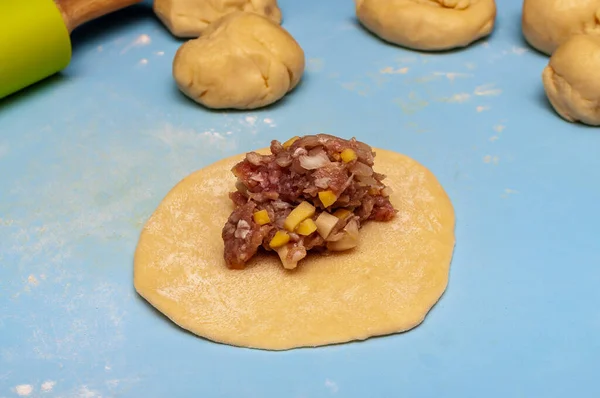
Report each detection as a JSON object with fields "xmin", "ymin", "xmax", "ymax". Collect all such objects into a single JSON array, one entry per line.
[{"xmin": 356, "ymin": 0, "xmax": 496, "ymax": 50}]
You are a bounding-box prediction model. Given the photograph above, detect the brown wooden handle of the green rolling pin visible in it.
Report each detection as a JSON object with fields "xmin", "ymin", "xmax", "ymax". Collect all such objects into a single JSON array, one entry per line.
[{"xmin": 55, "ymin": 0, "xmax": 142, "ymax": 33}]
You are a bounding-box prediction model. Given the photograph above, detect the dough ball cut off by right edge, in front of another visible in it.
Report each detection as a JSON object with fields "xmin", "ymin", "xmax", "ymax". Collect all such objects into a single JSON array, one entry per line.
[{"xmin": 542, "ymin": 35, "xmax": 600, "ymax": 126}]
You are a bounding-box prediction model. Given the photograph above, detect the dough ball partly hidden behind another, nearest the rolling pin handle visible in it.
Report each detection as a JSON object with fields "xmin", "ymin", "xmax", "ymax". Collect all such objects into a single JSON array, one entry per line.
[{"xmin": 154, "ymin": 0, "xmax": 281, "ymax": 38}]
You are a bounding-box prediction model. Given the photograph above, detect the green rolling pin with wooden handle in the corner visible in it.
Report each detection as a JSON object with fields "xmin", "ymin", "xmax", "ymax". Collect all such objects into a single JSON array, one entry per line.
[{"xmin": 0, "ymin": 0, "xmax": 141, "ymax": 99}]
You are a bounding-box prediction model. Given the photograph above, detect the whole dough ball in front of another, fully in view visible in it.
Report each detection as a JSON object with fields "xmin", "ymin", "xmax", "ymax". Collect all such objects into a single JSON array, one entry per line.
[{"xmin": 173, "ymin": 11, "xmax": 305, "ymax": 109}]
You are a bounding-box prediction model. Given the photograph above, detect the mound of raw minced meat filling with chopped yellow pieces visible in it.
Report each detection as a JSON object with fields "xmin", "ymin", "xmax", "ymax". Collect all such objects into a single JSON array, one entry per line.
[{"xmin": 222, "ymin": 134, "xmax": 397, "ymax": 269}]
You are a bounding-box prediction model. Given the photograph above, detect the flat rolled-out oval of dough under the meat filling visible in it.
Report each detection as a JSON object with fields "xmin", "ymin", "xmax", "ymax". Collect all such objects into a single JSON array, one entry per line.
[{"xmin": 134, "ymin": 149, "xmax": 454, "ymax": 350}]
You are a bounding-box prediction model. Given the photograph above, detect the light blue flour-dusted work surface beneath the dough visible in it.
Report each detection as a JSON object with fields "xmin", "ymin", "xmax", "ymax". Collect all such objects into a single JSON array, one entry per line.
[{"xmin": 0, "ymin": 0, "xmax": 600, "ymax": 398}]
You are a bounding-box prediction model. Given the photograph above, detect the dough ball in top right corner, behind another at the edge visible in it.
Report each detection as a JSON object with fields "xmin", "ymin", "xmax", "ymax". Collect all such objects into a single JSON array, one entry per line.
[{"xmin": 521, "ymin": 0, "xmax": 600, "ymax": 55}]
